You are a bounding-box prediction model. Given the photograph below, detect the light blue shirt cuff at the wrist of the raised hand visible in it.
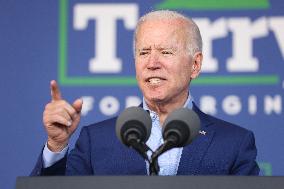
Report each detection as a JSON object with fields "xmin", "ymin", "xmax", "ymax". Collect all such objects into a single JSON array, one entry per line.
[{"xmin": 42, "ymin": 143, "xmax": 68, "ymax": 168}]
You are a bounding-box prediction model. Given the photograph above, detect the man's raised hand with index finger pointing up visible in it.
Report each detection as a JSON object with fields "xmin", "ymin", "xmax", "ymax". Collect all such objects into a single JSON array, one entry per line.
[{"xmin": 43, "ymin": 80, "xmax": 83, "ymax": 152}]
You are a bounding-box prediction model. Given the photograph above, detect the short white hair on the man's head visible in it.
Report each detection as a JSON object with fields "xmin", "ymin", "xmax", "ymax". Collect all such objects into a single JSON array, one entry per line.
[{"xmin": 133, "ymin": 10, "xmax": 202, "ymax": 57}]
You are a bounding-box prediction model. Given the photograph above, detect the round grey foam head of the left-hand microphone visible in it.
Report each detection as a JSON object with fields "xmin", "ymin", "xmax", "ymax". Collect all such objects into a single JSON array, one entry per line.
[{"xmin": 115, "ymin": 107, "xmax": 152, "ymax": 146}]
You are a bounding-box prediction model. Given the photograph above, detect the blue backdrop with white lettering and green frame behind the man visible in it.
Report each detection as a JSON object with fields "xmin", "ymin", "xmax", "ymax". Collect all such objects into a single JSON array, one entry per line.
[{"xmin": 0, "ymin": 0, "xmax": 284, "ymax": 188}]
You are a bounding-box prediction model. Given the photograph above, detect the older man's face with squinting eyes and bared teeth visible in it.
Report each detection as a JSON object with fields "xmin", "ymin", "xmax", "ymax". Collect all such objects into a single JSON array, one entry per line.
[{"xmin": 135, "ymin": 19, "xmax": 198, "ymax": 103}]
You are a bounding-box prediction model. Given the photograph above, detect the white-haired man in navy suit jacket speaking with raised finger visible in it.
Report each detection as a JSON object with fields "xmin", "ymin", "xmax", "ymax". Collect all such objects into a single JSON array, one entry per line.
[{"xmin": 32, "ymin": 11, "xmax": 259, "ymax": 175}]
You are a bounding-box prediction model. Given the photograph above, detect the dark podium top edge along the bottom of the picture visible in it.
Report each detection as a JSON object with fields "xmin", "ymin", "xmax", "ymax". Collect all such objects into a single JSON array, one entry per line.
[{"xmin": 16, "ymin": 176, "xmax": 284, "ymax": 189}]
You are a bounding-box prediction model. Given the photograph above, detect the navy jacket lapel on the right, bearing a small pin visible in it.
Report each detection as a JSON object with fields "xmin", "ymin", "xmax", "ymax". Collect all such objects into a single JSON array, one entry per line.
[{"xmin": 177, "ymin": 103, "xmax": 214, "ymax": 175}]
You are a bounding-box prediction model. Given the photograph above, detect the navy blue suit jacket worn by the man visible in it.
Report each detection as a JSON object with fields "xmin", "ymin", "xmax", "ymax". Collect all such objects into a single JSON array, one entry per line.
[{"xmin": 31, "ymin": 105, "xmax": 259, "ymax": 175}]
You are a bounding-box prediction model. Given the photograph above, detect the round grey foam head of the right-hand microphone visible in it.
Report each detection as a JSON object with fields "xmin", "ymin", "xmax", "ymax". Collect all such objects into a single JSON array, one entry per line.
[{"xmin": 163, "ymin": 108, "xmax": 200, "ymax": 147}]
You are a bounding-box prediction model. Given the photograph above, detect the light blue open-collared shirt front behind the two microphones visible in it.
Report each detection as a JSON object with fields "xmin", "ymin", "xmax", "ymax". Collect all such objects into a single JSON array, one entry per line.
[{"xmin": 143, "ymin": 95, "xmax": 192, "ymax": 175}]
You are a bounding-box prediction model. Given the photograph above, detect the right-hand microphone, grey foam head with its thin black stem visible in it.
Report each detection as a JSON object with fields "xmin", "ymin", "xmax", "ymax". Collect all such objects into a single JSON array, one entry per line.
[{"xmin": 150, "ymin": 108, "xmax": 200, "ymax": 174}]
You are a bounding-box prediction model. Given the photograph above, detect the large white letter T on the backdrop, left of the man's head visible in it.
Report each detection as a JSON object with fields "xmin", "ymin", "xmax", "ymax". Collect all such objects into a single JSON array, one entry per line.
[{"xmin": 74, "ymin": 3, "xmax": 138, "ymax": 73}]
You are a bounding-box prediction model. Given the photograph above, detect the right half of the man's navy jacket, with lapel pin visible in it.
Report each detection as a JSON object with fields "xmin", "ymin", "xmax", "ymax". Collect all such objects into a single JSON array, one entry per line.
[{"xmin": 178, "ymin": 104, "xmax": 259, "ymax": 175}]
